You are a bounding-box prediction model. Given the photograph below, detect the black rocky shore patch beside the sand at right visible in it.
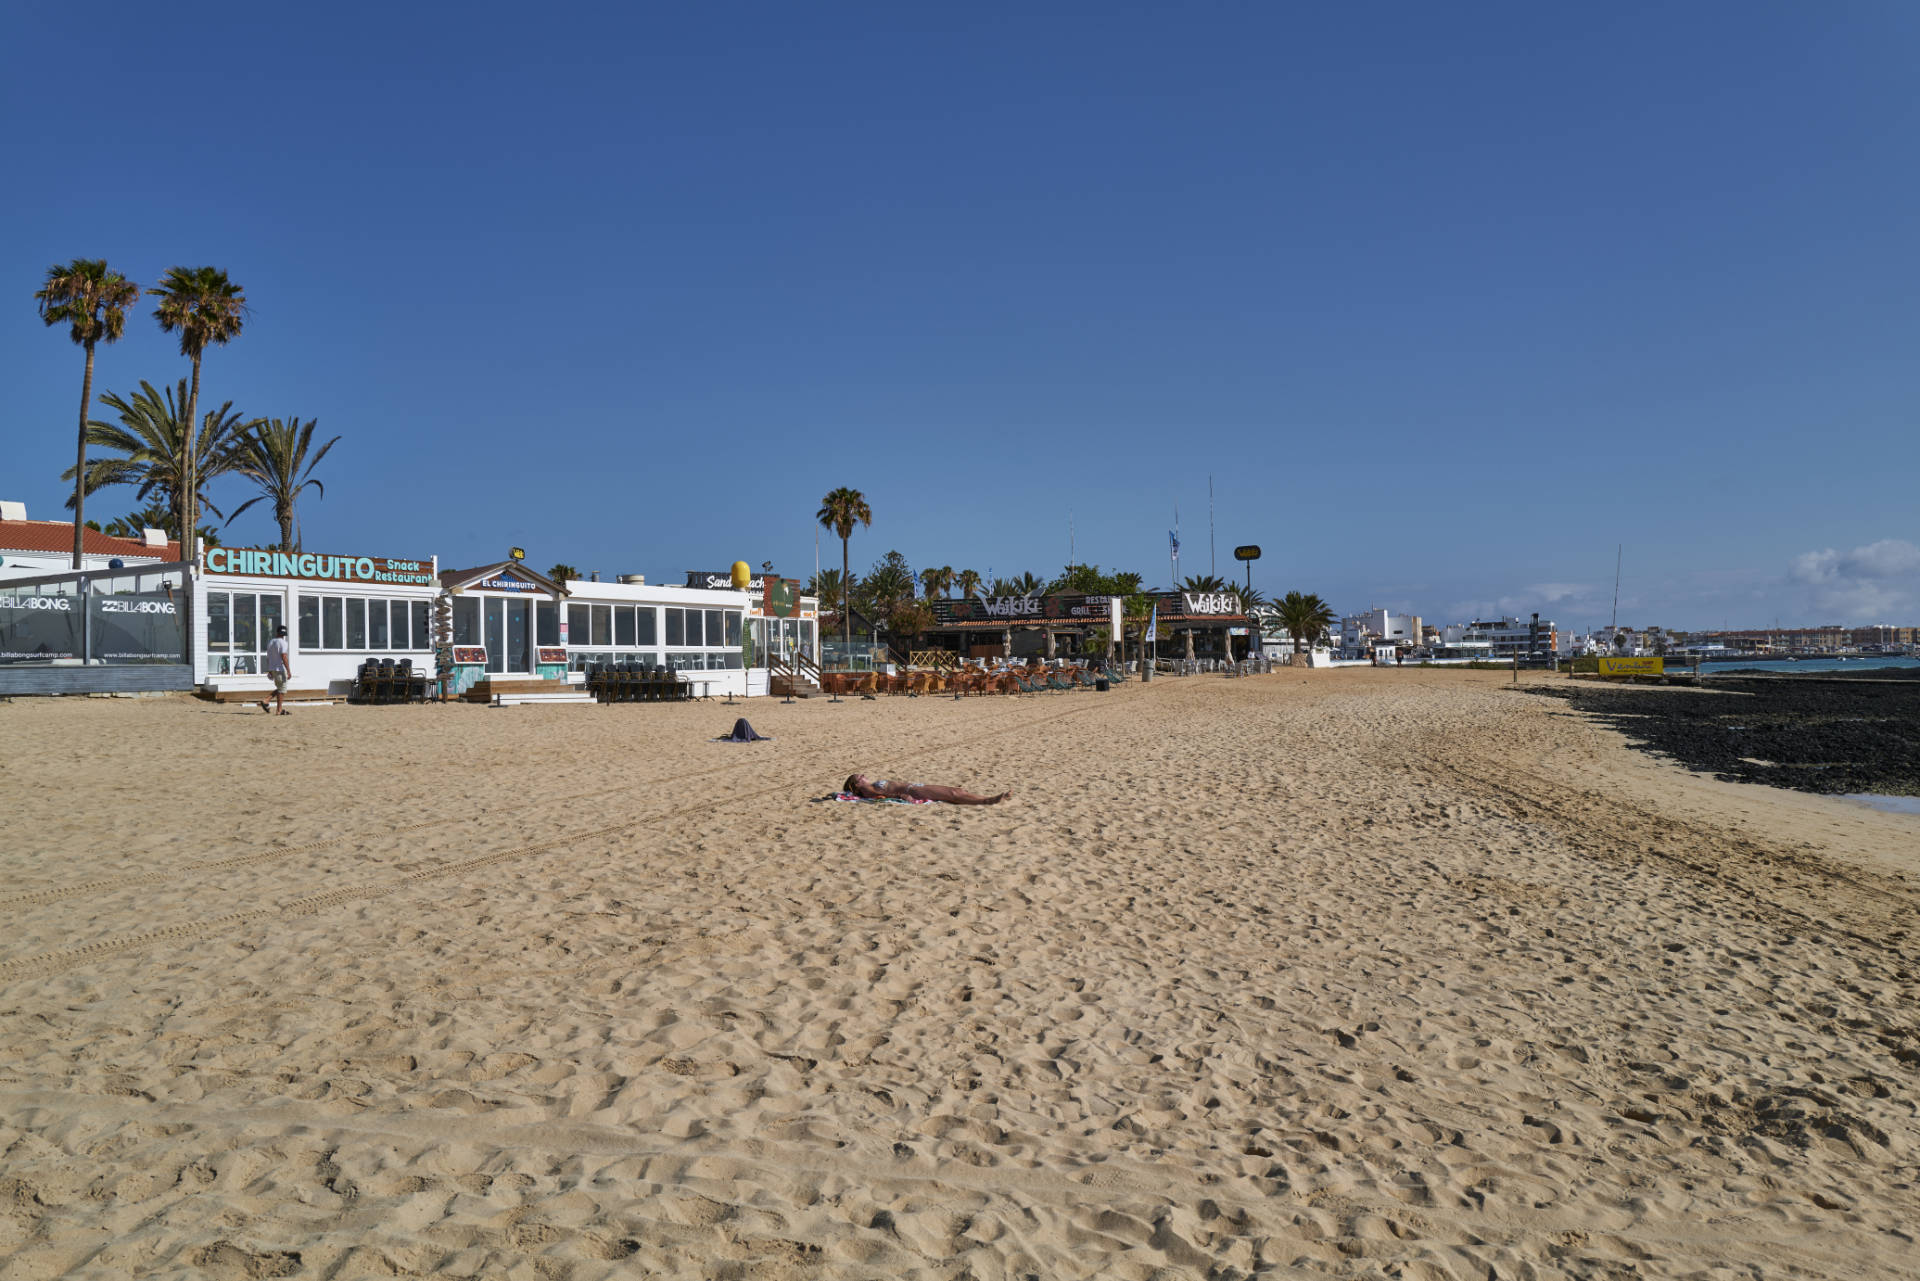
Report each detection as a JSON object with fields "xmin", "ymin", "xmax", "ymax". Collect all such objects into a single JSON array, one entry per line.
[{"xmin": 1532, "ymin": 672, "xmax": 1920, "ymax": 797}]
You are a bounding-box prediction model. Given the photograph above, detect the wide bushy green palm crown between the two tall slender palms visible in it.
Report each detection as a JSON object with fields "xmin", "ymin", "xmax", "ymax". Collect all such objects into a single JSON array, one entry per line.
[{"xmin": 61, "ymin": 378, "xmax": 246, "ymax": 541}]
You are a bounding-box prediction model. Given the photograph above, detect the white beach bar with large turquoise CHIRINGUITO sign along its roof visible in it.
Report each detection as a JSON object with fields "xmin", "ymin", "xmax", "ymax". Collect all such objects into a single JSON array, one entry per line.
[{"xmin": 192, "ymin": 547, "xmax": 440, "ymax": 701}]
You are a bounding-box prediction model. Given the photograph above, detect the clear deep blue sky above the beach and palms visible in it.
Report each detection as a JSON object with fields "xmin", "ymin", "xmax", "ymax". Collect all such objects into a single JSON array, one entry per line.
[{"xmin": 0, "ymin": 2, "xmax": 1920, "ymax": 626}]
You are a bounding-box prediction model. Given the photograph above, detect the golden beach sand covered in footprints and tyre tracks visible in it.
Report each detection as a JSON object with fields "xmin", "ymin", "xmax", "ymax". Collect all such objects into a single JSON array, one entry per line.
[{"xmin": 0, "ymin": 670, "xmax": 1920, "ymax": 1281}]
